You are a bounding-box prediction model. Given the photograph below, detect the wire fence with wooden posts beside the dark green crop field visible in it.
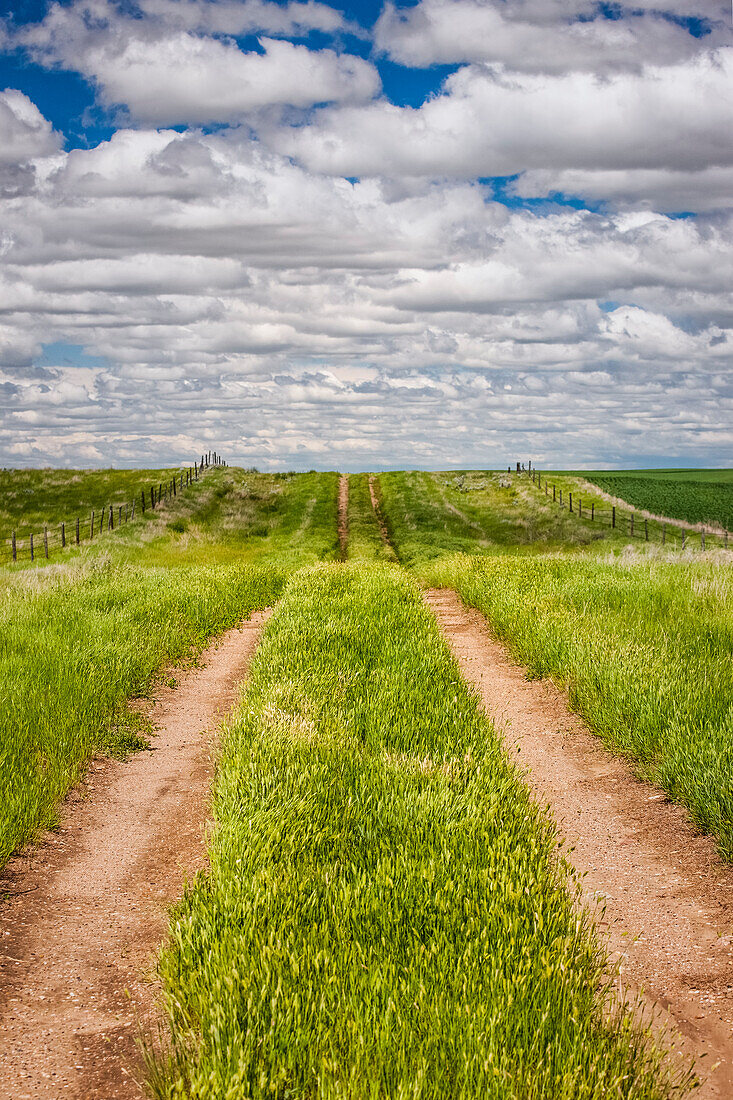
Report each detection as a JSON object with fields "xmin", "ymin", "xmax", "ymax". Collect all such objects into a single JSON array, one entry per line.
[{"xmin": 517, "ymin": 463, "xmax": 730, "ymax": 550}]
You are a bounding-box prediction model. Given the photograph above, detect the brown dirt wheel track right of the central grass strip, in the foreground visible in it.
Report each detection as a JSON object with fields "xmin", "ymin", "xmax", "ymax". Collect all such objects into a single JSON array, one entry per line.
[{"xmin": 425, "ymin": 590, "xmax": 733, "ymax": 1100}]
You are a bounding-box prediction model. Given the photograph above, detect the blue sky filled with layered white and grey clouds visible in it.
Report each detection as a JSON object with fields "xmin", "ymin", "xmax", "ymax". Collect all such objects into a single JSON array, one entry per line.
[{"xmin": 0, "ymin": 0, "xmax": 733, "ymax": 470}]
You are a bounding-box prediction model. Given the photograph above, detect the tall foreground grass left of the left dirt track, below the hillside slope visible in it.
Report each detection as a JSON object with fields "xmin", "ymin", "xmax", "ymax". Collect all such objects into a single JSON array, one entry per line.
[{"xmin": 0, "ymin": 562, "xmax": 284, "ymax": 864}]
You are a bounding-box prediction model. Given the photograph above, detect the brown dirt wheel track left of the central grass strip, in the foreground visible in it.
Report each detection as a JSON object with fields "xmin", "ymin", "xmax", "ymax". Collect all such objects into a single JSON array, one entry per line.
[{"xmin": 0, "ymin": 613, "xmax": 266, "ymax": 1100}]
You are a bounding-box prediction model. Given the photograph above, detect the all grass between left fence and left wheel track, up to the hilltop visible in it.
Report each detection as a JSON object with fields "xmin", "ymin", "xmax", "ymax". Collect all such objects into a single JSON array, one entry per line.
[{"xmin": 0, "ymin": 469, "xmax": 338, "ymax": 864}]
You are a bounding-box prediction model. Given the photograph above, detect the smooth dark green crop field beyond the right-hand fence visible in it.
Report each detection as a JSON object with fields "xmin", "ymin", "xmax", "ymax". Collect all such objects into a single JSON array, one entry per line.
[{"xmin": 584, "ymin": 470, "xmax": 733, "ymax": 530}]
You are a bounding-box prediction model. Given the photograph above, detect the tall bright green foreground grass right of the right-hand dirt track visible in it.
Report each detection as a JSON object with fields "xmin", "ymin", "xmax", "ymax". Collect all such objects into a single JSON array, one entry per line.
[{"xmin": 422, "ymin": 556, "xmax": 733, "ymax": 859}]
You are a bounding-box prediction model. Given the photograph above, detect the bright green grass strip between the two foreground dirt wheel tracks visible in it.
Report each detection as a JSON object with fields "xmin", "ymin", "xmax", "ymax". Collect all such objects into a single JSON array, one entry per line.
[{"xmin": 153, "ymin": 564, "xmax": 679, "ymax": 1100}]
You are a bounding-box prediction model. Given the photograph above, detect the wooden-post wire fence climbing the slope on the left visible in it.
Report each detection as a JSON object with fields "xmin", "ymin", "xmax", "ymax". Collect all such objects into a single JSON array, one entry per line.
[{"xmin": 0, "ymin": 451, "xmax": 227, "ymax": 564}]
